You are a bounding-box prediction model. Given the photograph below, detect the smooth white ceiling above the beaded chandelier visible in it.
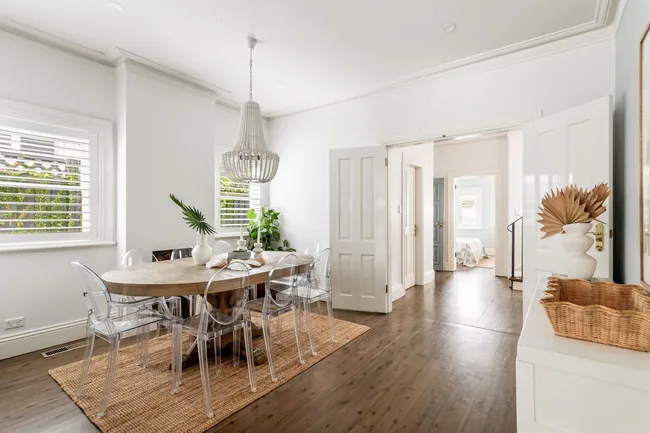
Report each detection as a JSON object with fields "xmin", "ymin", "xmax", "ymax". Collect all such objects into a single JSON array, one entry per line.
[{"xmin": 0, "ymin": 0, "xmax": 613, "ymax": 116}]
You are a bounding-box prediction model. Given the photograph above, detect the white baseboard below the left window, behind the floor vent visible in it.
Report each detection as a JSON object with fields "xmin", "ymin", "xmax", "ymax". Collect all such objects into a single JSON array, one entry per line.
[{"xmin": 0, "ymin": 318, "xmax": 86, "ymax": 359}]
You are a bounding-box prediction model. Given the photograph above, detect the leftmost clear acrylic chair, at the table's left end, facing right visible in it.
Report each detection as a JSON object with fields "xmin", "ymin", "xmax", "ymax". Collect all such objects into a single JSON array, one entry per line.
[{"xmin": 70, "ymin": 262, "xmax": 177, "ymax": 418}]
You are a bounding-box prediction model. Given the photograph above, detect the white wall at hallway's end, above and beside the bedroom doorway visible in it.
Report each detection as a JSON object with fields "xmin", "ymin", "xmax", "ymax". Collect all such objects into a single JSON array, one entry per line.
[{"xmin": 433, "ymin": 135, "xmax": 509, "ymax": 276}]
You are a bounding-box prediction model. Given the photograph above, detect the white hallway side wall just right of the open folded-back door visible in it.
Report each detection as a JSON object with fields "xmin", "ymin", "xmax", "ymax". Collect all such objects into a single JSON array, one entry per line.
[{"xmin": 388, "ymin": 143, "xmax": 434, "ymax": 301}]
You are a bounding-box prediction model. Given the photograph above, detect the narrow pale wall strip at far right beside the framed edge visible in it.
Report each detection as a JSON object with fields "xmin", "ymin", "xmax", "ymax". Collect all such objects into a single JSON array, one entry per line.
[{"xmin": 612, "ymin": 0, "xmax": 650, "ymax": 284}]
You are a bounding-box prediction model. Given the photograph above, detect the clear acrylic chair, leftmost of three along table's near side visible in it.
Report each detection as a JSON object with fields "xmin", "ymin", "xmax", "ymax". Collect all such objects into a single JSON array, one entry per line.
[{"xmin": 172, "ymin": 260, "xmax": 257, "ymax": 418}]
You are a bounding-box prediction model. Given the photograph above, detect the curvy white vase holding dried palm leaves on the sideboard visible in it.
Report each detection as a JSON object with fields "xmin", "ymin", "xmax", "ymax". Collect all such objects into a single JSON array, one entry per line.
[{"xmin": 562, "ymin": 223, "xmax": 598, "ymax": 280}]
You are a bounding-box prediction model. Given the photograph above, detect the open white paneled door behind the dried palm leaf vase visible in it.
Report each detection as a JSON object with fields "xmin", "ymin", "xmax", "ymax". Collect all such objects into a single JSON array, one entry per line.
[{"xmin": 523, "ymin": 96, "xmax": 612, "ymax": 314}]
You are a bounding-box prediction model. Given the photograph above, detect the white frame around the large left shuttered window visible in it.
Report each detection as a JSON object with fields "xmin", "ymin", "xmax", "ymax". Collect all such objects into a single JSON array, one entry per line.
[{"xmin": 0, "ymin": 98, "xmax": 115, "ymax": 252}]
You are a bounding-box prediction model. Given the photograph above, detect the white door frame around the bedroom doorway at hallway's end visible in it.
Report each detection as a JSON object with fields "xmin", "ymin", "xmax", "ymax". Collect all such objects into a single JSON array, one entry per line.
[{"xmin": 443, "ymin": 169, "xmax": 508, "ymax": 277}]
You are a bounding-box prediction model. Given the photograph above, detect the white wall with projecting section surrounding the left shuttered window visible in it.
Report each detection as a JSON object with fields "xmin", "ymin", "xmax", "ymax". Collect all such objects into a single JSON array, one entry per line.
[{"xmin": 0, "ymin": 32, "xmax": 239, "ymax": 359}]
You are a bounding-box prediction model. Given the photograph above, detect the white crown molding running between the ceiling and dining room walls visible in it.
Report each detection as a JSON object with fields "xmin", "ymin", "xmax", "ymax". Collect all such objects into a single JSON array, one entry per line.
[{"xmin": 0, "ymin": 0, "xmax": 627, "ymax": 120}]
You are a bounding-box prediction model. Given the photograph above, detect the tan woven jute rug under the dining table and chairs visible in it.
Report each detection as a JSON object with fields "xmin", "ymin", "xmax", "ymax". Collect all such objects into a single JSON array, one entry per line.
[{"xmin": 49, "ymin": 314, "xmax": 370, "ymax": 433}]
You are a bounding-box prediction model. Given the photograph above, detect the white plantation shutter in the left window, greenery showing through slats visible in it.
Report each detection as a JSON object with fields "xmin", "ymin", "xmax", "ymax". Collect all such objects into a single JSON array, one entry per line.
[{"xmin": 0, "ymin": 123, "xmax": 92, "ymax": 235}]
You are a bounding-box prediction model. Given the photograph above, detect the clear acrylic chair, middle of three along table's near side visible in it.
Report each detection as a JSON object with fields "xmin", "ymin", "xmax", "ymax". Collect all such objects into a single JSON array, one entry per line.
[{"xmin": 248, "ymin": 254, "xmax": 305, "ymax": 382}]
